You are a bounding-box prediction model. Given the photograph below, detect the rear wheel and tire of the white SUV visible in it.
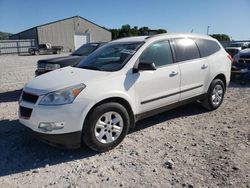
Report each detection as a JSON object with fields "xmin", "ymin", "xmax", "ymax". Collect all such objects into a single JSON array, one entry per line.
[{"xmin": 201, "ymin": 79, "xmax": 225, "ymax": 111}]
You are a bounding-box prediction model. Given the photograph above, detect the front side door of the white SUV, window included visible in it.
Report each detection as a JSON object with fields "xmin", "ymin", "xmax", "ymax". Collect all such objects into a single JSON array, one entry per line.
[{"xmin": 135, "ymin": 40, "xmax": 180, "ymax": 113}]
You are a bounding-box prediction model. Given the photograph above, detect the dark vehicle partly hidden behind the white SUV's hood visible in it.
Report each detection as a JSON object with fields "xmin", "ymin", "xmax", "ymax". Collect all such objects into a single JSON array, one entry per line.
[{"xmin": 35, "ymin": 42, "xmax": 104, "ymax": 76}]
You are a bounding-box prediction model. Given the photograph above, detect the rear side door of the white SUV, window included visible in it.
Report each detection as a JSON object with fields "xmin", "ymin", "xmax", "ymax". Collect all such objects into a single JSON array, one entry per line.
[{"xmin": 174, "ymin": 38, "xmax": 209, "ymax": 100}]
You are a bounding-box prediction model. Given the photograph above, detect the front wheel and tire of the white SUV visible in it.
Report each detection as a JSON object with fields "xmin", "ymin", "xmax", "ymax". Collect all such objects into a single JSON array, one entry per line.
[{"xmin": 82, "ymin": 102, "xmax": 130, "ymax": 152}]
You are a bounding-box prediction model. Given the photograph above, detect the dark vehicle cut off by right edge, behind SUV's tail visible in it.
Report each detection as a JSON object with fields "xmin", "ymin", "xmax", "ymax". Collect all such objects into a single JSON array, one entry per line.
[{"xmin": 231, "ymin": 48, "xmax": 250, "ymax": 83}]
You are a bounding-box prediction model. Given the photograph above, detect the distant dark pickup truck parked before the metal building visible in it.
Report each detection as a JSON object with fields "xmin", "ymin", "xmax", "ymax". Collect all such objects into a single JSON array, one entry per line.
[{"xmin": 28, "ymin": 43, "xmax": 63, "ymax": 55}]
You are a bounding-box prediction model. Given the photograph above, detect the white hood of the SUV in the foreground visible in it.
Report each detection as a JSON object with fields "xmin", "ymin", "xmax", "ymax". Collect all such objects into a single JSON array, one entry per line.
[{"xmin": 24, "ymin": 67, "xmax": 110, "ymax": 95}]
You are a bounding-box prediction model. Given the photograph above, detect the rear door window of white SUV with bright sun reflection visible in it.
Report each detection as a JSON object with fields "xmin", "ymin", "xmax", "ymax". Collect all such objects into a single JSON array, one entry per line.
[{"xmin": 174, "ymin": 38, "xmax": 200, "ymax": 62}]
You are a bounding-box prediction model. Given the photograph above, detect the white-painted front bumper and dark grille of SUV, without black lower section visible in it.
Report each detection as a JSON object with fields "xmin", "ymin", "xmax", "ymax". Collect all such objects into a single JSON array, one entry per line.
[{"xmin": 18, "ymin": 88, "xmax": 94, "ymax": 135}]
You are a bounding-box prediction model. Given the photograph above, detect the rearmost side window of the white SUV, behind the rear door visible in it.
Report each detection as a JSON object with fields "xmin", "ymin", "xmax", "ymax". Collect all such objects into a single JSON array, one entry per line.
[{"xmin": 194, "ymin": 39, "xmax": 220, "ymax": 57}]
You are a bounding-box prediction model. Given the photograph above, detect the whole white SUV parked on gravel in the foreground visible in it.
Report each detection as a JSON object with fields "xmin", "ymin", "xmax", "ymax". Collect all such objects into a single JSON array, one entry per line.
[{"xmin": 19, "ymin": 34, "xmax": 231, "ymax": 151}]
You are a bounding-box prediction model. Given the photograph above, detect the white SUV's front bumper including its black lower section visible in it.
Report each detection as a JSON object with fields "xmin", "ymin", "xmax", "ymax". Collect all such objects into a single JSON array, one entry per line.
[{"xmin": 18, "ymin": 99, "xmax": 91, "ymax": 149}]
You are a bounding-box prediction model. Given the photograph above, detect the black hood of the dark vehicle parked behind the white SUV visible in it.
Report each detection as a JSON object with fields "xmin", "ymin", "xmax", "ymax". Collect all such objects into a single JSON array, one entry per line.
[{"xmin": 38, "ymin": 55, "xmax": 86, "ymax": 67}]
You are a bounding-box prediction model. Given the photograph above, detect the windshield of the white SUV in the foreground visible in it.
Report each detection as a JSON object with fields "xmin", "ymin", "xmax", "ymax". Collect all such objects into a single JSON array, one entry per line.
[{"xmin": 78, "ymin": 42, "xmax": 145, "ymax": 71}]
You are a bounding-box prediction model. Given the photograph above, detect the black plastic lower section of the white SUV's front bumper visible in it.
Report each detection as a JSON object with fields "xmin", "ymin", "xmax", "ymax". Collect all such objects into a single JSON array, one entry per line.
[{"xmin": 23, "ymin": 125, "xmax": 82, "ymax": 149}]
